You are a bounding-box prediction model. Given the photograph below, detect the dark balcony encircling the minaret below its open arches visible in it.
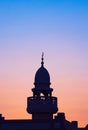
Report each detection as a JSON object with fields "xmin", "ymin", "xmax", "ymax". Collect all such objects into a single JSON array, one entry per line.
[{"xmin": 27, "ymin": 96, "xmax": 57, "ymax": 113}]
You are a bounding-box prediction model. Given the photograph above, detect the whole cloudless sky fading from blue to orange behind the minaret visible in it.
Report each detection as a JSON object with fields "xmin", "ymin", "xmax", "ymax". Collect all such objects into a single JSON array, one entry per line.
[{"xmin": 0, "ymin": 0, "xmax": 88, "ymax": 126}]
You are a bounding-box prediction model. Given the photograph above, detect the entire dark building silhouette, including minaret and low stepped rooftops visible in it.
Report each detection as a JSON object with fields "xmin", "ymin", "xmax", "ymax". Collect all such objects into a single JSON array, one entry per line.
[{"xmin": 0, "ymin": 55, "xmax": 88, "ymax": 130}]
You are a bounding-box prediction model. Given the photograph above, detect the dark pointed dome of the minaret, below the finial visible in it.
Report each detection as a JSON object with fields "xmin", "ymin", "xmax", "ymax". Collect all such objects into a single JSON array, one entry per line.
[{"xmin": 34, "ymin": 66, "xmax": 50, "ymax": 87}]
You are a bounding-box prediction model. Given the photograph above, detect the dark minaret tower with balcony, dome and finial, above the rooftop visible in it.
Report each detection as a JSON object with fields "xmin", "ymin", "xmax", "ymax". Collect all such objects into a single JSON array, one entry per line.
[{"xmin": 27, "ymin": 53, "xmax": 58, "ymax": 120}]
